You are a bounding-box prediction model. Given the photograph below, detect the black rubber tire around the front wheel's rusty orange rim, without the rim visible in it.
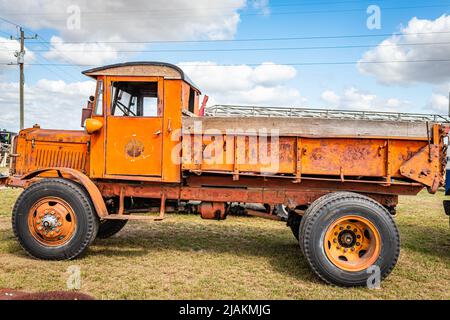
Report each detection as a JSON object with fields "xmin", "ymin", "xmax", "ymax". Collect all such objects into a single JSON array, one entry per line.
[{"xmin": 12, "ymin": 179, "xmax": 99, "ymax": 260}]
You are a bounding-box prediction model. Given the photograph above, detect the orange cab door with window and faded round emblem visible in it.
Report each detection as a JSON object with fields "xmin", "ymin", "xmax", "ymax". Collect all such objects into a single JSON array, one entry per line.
[{"xmin": 105, "ymin": 77, "xmax": 164, "ymax": 177}]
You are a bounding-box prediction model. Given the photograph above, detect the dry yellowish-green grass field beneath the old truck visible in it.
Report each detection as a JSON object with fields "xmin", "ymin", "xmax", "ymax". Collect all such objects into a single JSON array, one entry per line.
[{"xmin": 0, "ymin": 180, "xmax": 450, "ymax": 299}]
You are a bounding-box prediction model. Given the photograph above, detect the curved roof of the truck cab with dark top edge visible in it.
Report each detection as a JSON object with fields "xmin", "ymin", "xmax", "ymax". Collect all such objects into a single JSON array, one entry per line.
[{"xmin": 82, "ymin": 61, "xmax": 200, "ymax": 93}]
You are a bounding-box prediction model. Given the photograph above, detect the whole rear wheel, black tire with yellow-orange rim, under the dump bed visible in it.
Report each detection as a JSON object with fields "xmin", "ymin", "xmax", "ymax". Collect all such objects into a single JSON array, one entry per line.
[{"xmin": 300, "ymin": 192, "xmax": 400, "ymax": 286}]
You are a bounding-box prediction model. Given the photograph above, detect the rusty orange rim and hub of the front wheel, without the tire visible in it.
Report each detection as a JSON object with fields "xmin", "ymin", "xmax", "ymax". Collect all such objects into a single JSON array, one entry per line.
[{"xmin": 28, "ymin": 197, "xmax": 77, "ymax": 247}]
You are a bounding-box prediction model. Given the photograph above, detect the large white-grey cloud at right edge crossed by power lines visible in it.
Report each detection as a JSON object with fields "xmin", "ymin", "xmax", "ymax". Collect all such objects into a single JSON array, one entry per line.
[{"xmin": 358, "ymin": 15, "xmax": 450, "ymax": 85}]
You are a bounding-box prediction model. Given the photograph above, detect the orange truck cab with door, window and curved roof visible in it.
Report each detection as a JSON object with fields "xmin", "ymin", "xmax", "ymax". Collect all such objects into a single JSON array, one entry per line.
[{"xmin": 83, "ymin": 62, "xmax": 200, "ymax": 182}]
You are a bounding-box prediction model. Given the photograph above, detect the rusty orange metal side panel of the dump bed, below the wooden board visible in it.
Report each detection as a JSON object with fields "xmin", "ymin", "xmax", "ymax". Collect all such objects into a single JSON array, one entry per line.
[{"xmin": 182, "ymin": 124, "xmax": 446, "ymax": 190}]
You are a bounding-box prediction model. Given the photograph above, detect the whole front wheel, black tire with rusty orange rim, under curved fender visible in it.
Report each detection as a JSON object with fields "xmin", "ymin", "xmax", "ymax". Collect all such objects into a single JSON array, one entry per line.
[{"xmin": 12, "ymin": 179, "xmax": 99, "ymax": 260}]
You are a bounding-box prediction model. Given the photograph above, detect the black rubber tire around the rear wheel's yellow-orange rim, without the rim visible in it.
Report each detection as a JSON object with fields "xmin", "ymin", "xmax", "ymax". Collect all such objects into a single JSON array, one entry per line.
[{"xmin": 299, "ymin": 192, "xmax": 400, "ymax": 286}]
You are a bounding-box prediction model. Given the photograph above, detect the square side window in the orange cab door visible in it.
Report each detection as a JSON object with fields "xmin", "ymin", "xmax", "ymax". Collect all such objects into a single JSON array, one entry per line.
[{"xmin": 111, "ymin": 82, "xmax": 162, "ymax": 117}]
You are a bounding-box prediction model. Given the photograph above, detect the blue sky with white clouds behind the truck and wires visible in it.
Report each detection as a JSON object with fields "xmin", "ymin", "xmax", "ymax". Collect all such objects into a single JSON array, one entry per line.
[{"xmin": 0, "ymin": 0, "xmax": 450, "ymax": 129}]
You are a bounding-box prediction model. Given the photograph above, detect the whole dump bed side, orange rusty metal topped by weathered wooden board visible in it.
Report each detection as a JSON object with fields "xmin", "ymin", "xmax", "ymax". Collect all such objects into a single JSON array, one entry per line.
[{"xmin": 182, "ymin": 109, "xmax": 447, "ymax": 191}]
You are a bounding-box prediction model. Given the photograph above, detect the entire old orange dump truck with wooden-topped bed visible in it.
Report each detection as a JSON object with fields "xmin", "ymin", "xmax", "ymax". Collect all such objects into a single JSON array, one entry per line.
[{"xmin": 0, "ymin": 62, "xmax": 448, "ymax": 286}]
